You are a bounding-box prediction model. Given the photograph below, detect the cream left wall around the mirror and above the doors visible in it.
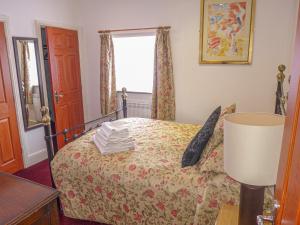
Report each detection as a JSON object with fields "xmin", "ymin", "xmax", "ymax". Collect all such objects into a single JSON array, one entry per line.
[{"xmin": 0, "ymin": 0, "xmax": 74, "ymax": 166}]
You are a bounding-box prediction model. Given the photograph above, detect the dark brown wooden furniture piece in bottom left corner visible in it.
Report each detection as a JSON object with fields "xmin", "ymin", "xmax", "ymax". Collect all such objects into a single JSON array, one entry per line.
[{"xmin": 0, "ymin": 173, "xmax": 59, "ymax": 225}]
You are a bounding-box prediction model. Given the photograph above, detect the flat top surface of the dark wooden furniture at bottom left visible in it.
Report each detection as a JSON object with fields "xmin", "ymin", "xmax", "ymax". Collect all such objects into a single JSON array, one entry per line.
[{"xmin": 0, "ymin": 173, "xmax": 59, "ymax": 224}]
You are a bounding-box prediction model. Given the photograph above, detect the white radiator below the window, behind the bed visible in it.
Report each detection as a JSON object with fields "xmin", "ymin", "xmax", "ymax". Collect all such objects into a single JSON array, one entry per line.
[{"xmin": 127, "ymin": 101, "xmax": 151, "ymax": 118}]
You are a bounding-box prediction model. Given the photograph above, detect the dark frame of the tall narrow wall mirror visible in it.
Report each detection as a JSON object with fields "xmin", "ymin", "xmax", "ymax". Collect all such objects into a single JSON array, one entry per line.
[{"xmin": 12, "ymin": 37, "xmax": 45, "ymax": 131}]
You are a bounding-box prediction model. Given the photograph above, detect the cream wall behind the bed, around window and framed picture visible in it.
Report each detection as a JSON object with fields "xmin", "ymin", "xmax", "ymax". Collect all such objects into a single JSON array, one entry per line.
[{"xmin": 76, "ymin": 0, "xmax": 298, "ymax": 122}]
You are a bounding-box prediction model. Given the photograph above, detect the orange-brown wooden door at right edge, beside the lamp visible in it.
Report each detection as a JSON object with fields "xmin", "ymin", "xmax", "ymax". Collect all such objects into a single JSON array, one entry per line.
[{"xmin": 275, "ymin": 3, "xmax": 300, "ymax": 225}]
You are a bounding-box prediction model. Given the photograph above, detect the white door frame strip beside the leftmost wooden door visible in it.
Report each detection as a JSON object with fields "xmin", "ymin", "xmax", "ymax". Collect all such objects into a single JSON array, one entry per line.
[{"xmin": 0, "ymin": 15, "xmax": 26, "ymax": 165}]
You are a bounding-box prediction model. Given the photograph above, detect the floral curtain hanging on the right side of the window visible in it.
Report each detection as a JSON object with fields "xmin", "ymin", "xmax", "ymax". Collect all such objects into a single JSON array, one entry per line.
[{"xmin": 151, "ymin": 28, "xmax": 176, "ymax": 120}]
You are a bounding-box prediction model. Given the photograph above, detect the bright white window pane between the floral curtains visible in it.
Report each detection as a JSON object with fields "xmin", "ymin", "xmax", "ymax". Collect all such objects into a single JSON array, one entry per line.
[{"xmin": 113, "ymin": 34, "xmax": 156, "ymax": 93}]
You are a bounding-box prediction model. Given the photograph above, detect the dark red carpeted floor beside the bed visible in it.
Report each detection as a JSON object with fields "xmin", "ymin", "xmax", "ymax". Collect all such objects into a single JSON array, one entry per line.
[{"xmin": 15, "ymin": 160, "xmax": 109, "ymax": 225}]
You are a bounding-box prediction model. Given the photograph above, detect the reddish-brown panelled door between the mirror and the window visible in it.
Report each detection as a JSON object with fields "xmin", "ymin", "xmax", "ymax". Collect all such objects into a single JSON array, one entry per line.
[{"xmin": 46, "ymin": 27, "xmax": 84, "ymax": 149}]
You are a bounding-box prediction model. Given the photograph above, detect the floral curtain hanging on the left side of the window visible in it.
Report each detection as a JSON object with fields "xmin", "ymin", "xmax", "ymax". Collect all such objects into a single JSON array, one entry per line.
[{"xmin": 100, "ymin": 33, "xmax": 117, "ymax": 115}]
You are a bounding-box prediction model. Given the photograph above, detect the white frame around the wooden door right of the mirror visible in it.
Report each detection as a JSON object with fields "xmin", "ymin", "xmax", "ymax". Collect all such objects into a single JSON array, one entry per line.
[{"xmin": 35, "ymin": 20, "xmax": 88, "ymax": 121}]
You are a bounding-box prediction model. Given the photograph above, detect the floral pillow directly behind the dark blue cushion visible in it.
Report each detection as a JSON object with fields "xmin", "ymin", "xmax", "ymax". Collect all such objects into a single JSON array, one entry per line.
[{"xmin": 199, "ymin": 104, "xmax": 236, "ymax": 166}]
